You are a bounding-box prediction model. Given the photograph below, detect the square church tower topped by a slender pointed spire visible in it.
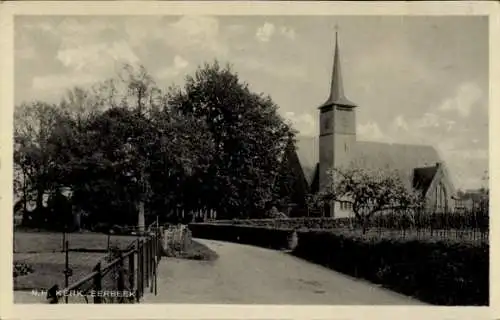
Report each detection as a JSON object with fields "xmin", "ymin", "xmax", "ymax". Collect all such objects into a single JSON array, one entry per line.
[{"xmin": 319, "ymin": 31, "xmax": 357, "ymax": 217}]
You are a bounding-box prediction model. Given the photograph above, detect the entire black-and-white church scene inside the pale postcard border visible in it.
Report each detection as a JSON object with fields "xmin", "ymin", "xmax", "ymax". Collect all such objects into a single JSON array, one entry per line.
[{"xmin": 1, "ymin": 1, "xmax": 491, "ymax": 318}]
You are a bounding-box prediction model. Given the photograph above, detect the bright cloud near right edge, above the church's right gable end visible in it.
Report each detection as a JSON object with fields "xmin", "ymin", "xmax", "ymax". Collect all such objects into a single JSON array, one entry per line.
[{"xmin": 438, "ymin": 82, "xmax": 483, "ymax": 118}]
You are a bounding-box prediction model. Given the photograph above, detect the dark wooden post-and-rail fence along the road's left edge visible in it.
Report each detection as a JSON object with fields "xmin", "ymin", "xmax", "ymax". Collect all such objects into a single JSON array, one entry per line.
[{"xmin": 47, "ymin": 223, "xmax": 163, "ymax": 303}]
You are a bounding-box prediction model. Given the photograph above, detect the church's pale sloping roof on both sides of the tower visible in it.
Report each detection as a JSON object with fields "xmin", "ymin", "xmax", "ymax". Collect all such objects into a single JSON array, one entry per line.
[{"xmin": 296, "ymin": 137, "xmax": 441, "ymax": 187}]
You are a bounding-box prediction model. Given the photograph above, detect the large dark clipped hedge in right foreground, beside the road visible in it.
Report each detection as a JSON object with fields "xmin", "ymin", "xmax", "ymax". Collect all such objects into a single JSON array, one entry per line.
[{"xmin": 294, "ymin": 230, "xmax": 489, "ymax": 306}]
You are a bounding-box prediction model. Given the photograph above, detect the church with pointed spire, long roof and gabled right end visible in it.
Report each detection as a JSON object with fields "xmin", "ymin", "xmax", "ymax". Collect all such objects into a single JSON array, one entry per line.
[{"xmin": 283, "ymin": 33, "xmax": 455, "ymax": 217}]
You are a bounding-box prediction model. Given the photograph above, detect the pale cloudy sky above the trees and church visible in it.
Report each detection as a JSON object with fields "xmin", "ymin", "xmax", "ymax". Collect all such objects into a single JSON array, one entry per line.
[{"xmin": 14, "ymin": 15, "xmax": 489, "ymax": 189}]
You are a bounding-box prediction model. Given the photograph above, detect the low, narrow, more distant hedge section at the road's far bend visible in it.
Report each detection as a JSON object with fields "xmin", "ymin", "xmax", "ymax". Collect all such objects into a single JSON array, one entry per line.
[{"xmin": 189, "ymin": 223, "xmax": 293, "ymax": 250}]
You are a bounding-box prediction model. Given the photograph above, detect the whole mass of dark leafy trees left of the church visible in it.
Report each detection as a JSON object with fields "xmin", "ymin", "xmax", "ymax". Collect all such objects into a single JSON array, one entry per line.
[{"xmin": 15, "ymin": 63, "xmax": 293, "ymax": 228}]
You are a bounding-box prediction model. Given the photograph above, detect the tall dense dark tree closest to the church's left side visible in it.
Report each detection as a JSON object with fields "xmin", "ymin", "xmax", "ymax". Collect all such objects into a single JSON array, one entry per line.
[{"xmin": 168, "ymin": 62, "xmax": 293, "ymax": 218}]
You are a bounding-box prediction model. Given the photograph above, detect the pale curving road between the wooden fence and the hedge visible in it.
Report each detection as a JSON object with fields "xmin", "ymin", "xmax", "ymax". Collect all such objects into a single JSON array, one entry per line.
[{"xmin": 143, "ymin": 239, "xmax": 425, "ymax": 305}]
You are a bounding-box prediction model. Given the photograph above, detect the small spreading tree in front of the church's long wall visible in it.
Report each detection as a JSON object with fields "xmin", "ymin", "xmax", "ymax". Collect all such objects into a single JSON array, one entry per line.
[{"xmin": 316, "ymin": 168, "xmax": 424, "ymax": 233}]
